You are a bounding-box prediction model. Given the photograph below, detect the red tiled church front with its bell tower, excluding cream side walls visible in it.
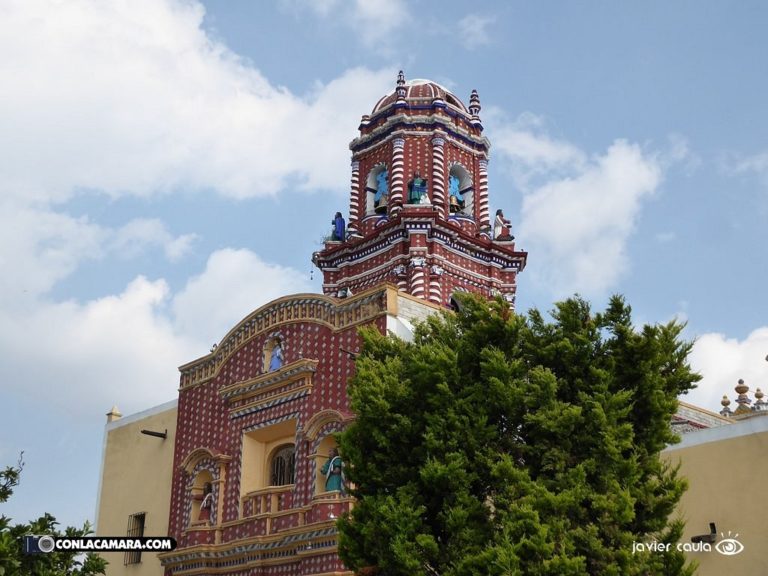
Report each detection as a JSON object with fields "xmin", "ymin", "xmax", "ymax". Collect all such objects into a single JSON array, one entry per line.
[{"xmin": 160, "ymin": 73, "xmax": 527, "ymax": 576}]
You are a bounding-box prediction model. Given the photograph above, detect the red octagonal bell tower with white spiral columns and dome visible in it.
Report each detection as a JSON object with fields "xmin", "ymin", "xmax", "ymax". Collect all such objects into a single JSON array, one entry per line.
[{"xmin": 313, "ymin": 71, "xmax": 528, "ymax": 306}]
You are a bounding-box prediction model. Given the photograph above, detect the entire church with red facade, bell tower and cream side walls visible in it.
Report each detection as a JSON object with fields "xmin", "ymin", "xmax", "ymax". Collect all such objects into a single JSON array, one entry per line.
[{"xmin": 96, "ymin": 73, "xmax": 768, "ymax": 576}]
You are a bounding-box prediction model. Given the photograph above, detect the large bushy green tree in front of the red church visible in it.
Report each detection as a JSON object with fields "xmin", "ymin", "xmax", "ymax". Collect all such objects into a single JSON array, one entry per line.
[{"xmin": 339, "ymin": 297, "xmax": 699, "ymax": 576}]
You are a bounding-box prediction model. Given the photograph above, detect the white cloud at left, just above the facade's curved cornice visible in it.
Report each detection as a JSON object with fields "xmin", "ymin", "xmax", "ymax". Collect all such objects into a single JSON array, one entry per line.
[{"xmin": 0, "ymin": 249, "xmax": 309, "ymax": 417}]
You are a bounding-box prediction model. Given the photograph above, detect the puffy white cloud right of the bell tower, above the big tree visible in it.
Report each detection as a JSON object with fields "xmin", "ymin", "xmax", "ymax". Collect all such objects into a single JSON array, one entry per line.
[{"xmin": 499, "ymin": 124, "xmax": 662, "ymax": 297}]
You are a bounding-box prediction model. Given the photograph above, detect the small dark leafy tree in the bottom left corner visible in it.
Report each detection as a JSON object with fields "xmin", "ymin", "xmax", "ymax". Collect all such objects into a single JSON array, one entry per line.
[{"xmin": 0, "ymin": 457, "xmax": 107, "ymax": 576}]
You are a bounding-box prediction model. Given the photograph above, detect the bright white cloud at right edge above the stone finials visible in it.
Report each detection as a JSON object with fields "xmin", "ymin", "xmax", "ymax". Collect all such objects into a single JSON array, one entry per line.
[{"xmin": 682, "ymin": 327, "xmax": 768, "ymax": 412}]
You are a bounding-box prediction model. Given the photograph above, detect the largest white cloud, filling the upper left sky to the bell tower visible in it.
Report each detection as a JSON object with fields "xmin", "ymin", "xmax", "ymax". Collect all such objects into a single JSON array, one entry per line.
[{"xmin": 0, "ymin": 0, "xmax": 395, "ymax": 202}]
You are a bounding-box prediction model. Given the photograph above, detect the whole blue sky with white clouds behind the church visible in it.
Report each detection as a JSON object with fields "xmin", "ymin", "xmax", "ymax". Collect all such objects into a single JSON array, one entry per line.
[{"xmin": 0, "ymin": 0, "xmax": 768, "ymax": 524}]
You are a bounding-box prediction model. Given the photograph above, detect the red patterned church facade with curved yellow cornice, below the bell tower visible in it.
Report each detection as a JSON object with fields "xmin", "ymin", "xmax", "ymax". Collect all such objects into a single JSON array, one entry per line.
[{"xmin": 162, "ymin": 286, "xmax": 394, "ymax": 576}]
